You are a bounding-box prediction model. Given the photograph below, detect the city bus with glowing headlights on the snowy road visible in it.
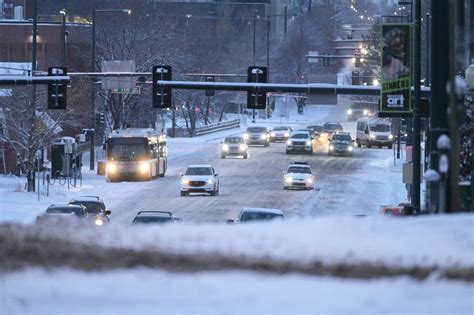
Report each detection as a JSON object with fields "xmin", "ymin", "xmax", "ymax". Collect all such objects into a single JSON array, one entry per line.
[{"xmin": 105, "ymin": 128, "xmax": 168, "ymax": 182}]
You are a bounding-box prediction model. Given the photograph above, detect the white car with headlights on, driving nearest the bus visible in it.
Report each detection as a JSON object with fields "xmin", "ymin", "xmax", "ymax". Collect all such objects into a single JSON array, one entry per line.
[{"xmin": 181, "ymin": 164, "xmax": 219, "ymax": 196}]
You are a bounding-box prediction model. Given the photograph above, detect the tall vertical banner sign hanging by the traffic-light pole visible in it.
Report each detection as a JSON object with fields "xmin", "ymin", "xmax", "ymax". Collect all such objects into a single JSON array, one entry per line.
[{"xmin": 379, "ymin": 24, "xmax": 413, "ymax": 117}]
